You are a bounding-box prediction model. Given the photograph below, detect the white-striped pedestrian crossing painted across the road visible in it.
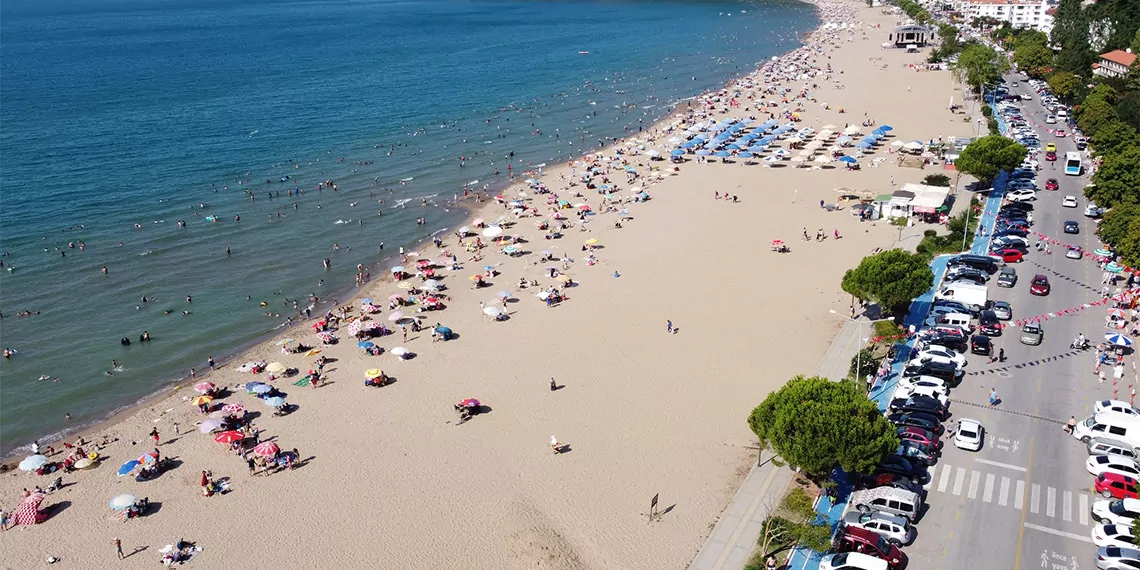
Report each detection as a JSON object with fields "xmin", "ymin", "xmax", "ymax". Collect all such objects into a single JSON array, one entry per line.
[{"xmin": 923, "ymin": 463, "xmax": 1097, "ymax": 527}]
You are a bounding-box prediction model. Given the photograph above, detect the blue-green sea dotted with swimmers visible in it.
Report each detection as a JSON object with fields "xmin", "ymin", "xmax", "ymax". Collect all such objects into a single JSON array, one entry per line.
[{"xmin": 0, "ymin": 0, "xmax": 819, "ymax": 455}]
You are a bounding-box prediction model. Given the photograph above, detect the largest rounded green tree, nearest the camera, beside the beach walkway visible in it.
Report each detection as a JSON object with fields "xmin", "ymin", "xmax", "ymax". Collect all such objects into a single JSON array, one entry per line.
[{"xmin": 748, "ymin": 376, "xmax": 898, "ymax": 481}]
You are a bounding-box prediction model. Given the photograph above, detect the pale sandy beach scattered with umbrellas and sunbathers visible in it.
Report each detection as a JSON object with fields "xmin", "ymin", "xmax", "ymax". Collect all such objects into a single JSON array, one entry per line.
[{"xmin": 0, "ymin": 2, "xmax": 972, "ymax": 569}]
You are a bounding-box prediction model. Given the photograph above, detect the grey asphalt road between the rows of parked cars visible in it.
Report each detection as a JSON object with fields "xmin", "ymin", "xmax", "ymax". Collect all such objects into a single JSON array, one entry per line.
[{"xmin": 904, "ymin": 79, "xmax": 1129, "ymax": 570}]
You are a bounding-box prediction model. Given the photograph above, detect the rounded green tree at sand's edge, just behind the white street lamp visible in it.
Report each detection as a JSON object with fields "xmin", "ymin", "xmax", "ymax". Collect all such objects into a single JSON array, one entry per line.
[{"xmin": 840, "ymin": 250, "xmax": 934, "ymax": 312}]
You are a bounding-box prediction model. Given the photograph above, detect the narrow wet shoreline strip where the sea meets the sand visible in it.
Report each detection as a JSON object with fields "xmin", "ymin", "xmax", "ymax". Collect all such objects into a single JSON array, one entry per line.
[{"xmin": 0, "ymin": 6, "xmax": 825, "ymax": 462}]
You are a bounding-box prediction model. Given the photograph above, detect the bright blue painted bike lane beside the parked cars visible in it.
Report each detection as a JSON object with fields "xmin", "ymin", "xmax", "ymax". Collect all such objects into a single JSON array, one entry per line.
[{"xmin": 784, "ymin": 93, "xmax": 1009, "ymax": 570}]
